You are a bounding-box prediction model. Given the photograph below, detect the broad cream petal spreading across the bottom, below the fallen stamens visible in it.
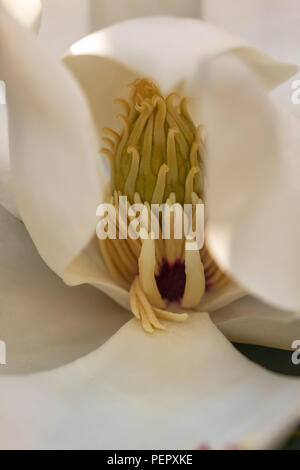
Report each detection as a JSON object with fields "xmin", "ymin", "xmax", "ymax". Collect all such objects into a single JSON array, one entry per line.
[{"xmin": 0, "ymin": 314, "xmax": 300, "ymax": 449}]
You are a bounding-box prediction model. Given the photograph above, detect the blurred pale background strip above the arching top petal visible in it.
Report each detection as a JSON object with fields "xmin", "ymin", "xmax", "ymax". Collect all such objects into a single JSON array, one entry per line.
[{"xmin": 40, "ymin": 0, "xmax": 300, "ymax": 63}]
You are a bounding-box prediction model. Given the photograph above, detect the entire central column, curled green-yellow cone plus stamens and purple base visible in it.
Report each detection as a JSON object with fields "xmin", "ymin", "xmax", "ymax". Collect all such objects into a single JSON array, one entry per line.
[{"xmin": 99, "ymin": 79, "xmax": 227, "ymax": 332}]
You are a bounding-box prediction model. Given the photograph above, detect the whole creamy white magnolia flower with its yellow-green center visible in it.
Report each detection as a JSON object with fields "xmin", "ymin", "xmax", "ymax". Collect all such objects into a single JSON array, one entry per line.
[{"xmin": 0, "ymin": 5, "xmax": 300, "ymax": 449}]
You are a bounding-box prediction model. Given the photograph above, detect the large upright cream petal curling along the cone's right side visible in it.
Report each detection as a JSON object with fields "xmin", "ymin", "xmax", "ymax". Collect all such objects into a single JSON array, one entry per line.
[{"xmin": 194, "ymin": 54, "xmax": 300, "ymax": 311}]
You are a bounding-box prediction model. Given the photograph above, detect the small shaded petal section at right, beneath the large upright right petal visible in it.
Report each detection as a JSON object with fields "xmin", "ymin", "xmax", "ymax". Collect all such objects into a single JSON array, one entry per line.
[{"xmin": 211, "ymin": 296, "xmax": 300, "ymax": 350}]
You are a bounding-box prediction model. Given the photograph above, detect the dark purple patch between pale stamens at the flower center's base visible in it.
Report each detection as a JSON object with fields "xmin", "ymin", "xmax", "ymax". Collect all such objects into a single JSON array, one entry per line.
[{"xmin": 156, "ymin": 260, "xmax": 186, "ymax": 302}]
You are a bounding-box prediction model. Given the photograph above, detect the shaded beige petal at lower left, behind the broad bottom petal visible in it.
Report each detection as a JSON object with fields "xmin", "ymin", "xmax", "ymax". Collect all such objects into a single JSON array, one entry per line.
[{"xmin": 0, "ymin": 202, "xmax": 131, "ymax": 374}]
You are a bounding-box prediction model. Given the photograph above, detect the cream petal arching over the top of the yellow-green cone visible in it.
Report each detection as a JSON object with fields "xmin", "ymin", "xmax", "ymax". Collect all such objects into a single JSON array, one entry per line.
[{"xmin": 64, "ymin": 17, "xmax": 298, "ymax": 142}]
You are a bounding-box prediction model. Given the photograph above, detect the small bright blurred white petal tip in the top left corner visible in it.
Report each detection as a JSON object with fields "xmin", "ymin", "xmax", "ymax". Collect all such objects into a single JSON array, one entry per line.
[{"xmin": 0, "ymin": 0, "xmax": 42, "ymax": 33}]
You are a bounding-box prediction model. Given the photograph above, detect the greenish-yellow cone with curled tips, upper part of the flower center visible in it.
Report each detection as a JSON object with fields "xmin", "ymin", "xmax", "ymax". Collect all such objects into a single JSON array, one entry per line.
[{"xmin": 101, "ymin": 79, "xmax": 203, "ymax": 204}]
